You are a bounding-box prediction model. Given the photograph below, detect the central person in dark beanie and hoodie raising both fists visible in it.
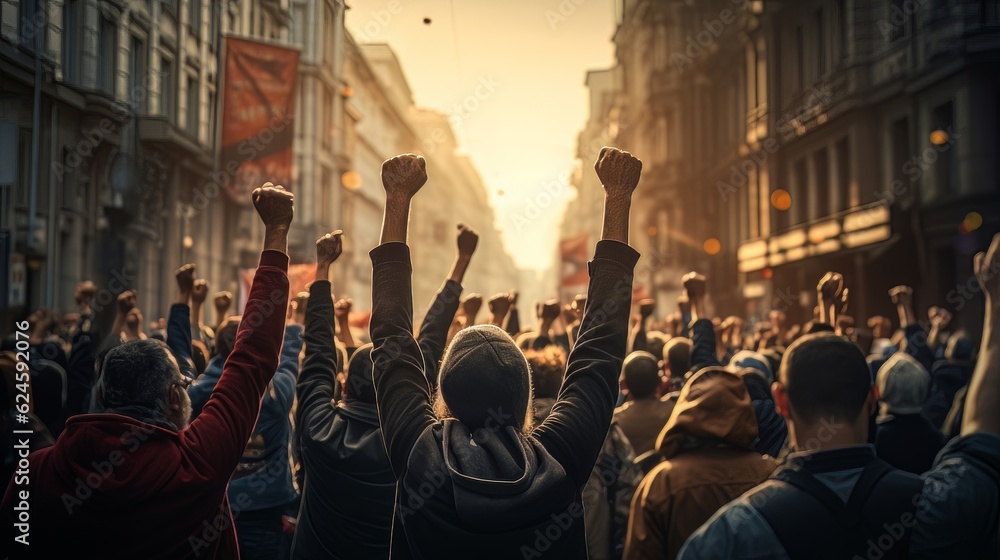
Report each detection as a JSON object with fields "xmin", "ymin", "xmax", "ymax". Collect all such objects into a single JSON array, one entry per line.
[{"xmin": 371, "ymin": 148, "xmax": 642, "ymax": 560}]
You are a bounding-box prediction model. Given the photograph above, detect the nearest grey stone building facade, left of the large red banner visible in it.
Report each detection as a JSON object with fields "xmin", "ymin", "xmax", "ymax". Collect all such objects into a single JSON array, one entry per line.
[{"xmin": 0, "ymin": 0, "xmax": 288, "ymax": 332}]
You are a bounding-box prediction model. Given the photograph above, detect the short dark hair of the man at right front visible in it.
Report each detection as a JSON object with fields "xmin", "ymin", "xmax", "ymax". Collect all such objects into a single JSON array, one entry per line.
[{"xmin": 778, "ymin": 332, "xmax": 872, "ymax": 423}]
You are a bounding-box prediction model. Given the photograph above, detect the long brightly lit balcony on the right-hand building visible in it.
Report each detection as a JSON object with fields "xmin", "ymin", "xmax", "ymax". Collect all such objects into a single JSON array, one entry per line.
[{"xmin": 736, "ymin": 200, "xmax": 892, "ymax": 272}]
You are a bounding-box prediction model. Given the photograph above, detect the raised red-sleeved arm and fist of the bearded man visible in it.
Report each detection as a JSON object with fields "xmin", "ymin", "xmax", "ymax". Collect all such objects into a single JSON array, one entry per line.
[{"xmin": 181, "ymin": 183, "xmax": 294, "ymax": 476}]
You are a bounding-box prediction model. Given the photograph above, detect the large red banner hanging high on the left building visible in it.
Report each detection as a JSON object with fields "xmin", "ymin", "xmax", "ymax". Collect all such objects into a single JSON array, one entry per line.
[{"xmin": 225, "ymin": 37, "xmax": 299, "ymax": 204}]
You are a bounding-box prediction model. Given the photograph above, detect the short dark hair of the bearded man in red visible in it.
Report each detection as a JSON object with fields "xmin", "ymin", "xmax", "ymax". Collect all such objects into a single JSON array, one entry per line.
[{"xmin": 97, "ymin": 338, "xmax": 180, "ymax": 411}]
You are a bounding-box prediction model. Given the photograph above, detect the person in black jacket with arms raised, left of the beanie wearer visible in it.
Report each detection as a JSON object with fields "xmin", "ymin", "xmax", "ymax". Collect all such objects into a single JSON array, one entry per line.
[{"xmin": 292, "ymin": 224, "xmax": 479, "ymax": 560}]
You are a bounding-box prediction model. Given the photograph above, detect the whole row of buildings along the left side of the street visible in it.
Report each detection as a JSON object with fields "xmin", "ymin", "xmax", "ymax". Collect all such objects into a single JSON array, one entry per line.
[{"xmin": 0, "ymin": 0, "xmax": 518, "ymax": 330}]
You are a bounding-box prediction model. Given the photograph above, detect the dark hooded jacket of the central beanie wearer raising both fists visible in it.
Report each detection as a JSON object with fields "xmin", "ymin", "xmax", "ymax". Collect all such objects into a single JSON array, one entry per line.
[{"xmin": 371, "ymin": 241, "xmax": 638, "ymax": 560}]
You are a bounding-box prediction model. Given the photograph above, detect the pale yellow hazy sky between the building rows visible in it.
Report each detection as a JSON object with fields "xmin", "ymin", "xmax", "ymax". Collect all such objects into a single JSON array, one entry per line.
[{"xmin": 346, "ymin": 0, "xmax": 615, "ymax": 270}]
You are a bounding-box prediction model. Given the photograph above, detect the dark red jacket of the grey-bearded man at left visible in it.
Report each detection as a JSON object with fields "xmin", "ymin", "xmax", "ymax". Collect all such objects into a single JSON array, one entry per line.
[{"xmin": 0, "ymin": 251, "xmax": 288, "ymax": 560}]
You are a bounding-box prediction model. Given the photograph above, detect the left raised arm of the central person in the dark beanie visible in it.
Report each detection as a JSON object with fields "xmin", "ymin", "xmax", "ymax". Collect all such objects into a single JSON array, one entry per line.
[{"xmin": 371, "ymin": 154, "xmax": 434, "ymax": 479}]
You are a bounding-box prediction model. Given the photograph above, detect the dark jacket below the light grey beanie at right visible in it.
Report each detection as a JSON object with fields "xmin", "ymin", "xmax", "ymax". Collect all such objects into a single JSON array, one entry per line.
[{"xmin": 875, "ymin": 414, "xmax": 947, "ymax": 474}]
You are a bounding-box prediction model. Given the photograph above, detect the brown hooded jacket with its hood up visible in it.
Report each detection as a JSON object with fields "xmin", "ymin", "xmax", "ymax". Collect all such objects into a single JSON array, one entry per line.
[{"xmin": 625, "ymin": 368, "xmax": 777, "ymax": 560}]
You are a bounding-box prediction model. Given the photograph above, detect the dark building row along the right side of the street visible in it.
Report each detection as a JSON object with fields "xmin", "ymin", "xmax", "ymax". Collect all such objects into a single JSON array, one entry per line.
[{"xmin": 563, "ymin": 0, "xmax": 1000, "ymax": 329}]
